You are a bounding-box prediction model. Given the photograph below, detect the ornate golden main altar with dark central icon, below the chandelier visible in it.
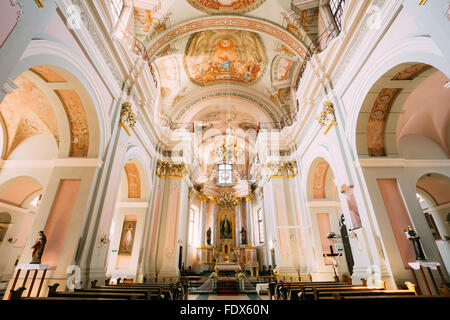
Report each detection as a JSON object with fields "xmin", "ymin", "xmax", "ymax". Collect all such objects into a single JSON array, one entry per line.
[{"xmin": 194, "ymin": 181, "xmax": 259, "ymax": 275}]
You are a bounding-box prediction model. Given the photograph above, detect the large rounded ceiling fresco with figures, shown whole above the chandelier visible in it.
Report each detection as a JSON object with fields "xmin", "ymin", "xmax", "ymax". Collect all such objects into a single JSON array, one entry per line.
[{"xmin": 184, "ymin": 30, "xmax": 267, "ymax": 86}]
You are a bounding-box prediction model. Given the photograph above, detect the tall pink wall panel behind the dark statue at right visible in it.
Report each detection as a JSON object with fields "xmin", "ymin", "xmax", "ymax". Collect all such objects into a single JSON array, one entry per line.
[{"xmin": 377, "ymin": 179, "xmax": 416, "ymax": 268}]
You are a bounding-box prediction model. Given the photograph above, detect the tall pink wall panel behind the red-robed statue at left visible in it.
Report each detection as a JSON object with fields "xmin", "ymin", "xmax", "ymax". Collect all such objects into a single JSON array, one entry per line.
[{"xmin": 42, "ymin": 180, "xmax": 81, "ymax": 268}]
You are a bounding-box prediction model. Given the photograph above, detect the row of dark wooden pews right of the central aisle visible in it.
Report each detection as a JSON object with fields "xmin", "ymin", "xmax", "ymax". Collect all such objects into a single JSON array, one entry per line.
[{"xmin": 269, "ymin": 281, "xmax": 450, "ymax": 300}]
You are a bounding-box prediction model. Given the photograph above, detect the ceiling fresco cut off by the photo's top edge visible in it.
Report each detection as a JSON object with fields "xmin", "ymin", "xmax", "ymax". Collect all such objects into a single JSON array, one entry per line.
[{"xmin": 186, "ymin": 0, "xmax": 266, "ymax": 14}]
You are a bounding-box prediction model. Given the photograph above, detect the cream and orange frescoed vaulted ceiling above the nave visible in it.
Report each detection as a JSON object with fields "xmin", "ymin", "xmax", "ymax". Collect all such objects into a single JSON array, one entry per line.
[{"xmin": 128, "ymin": 0, "xmax": 319, "ymax": 127}]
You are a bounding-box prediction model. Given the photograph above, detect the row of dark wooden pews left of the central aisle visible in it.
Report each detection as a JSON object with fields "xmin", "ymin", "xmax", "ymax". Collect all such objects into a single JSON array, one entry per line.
[{"xmin": 11, "ymin": 279, "xmax": 189, "ymax": 300}]
